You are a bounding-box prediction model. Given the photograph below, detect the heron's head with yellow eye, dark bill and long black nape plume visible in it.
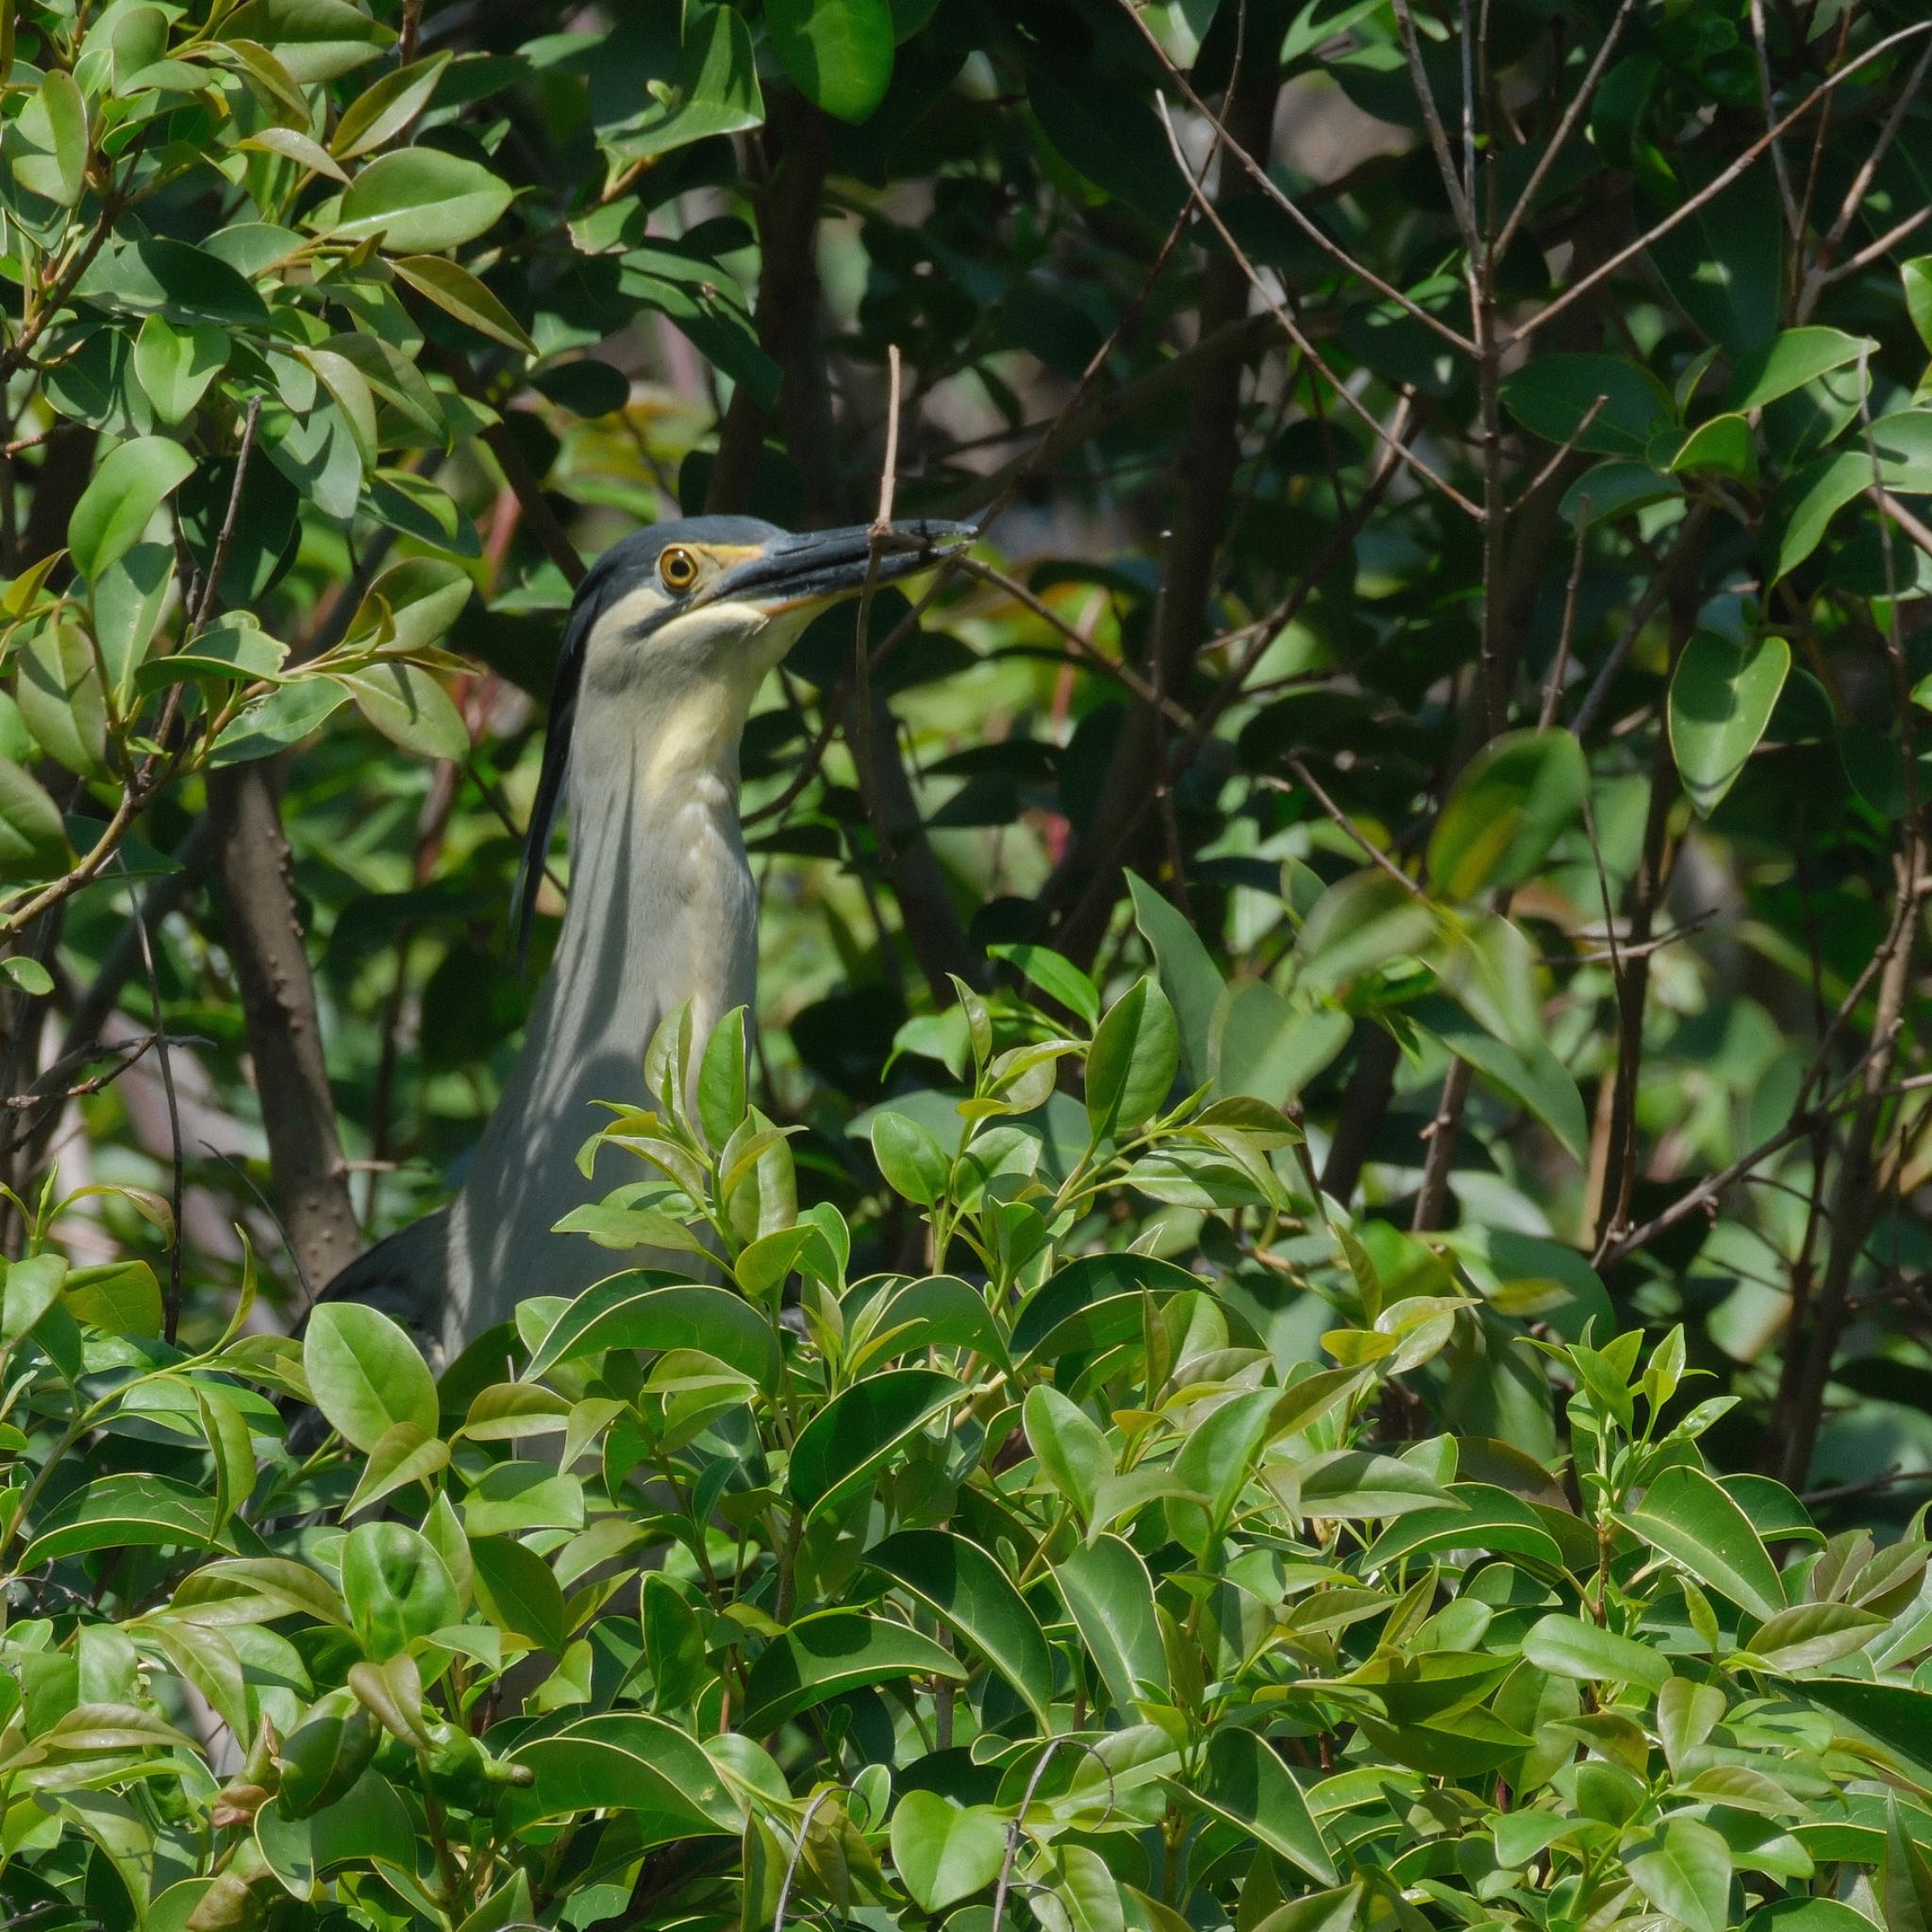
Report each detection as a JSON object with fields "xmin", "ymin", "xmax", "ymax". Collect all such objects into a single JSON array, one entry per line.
[{"xmin": 510, "ymin": 516, "xmax": 975, "ymax": 962}]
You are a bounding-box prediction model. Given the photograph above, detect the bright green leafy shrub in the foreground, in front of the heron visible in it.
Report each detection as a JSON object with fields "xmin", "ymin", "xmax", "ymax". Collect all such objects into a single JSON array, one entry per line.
[{"xmin": 0, "ymin": 949, "xmax": 1932, "ymax": 1932}]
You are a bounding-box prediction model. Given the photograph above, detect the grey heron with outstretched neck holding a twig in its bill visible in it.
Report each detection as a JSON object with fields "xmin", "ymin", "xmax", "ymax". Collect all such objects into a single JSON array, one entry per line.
[{"xmin": 323, "ymin": 516, "xmax": 974, "ymax": 1366}]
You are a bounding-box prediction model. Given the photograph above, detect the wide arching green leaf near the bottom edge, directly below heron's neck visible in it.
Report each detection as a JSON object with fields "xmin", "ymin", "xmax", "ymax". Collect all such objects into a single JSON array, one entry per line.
[{"xmin": 512, "ymin": 1712, "xmax": 738, "ymax": 1843}]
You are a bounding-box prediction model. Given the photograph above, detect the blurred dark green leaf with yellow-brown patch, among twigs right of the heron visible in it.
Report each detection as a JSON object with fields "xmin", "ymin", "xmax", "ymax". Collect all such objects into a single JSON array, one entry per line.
[{"xmin": 1427, "ymin": 730, "xmax": 1591, "ymax": 900}]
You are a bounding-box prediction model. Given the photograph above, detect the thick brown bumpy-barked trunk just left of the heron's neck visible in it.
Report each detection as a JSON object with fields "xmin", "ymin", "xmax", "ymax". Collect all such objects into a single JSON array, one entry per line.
[{"xmin": 208, "ymin": 763, "xmax": 361, "ymax": 1291}]
